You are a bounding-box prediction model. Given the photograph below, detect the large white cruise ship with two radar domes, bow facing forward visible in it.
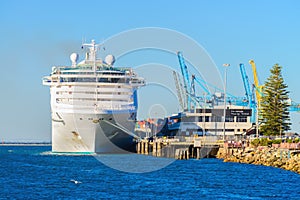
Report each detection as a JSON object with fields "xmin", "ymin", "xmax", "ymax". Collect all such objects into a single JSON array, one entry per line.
[{"xmin": 43, "ymin": 40, "xmax": 145, "ymax": 153}]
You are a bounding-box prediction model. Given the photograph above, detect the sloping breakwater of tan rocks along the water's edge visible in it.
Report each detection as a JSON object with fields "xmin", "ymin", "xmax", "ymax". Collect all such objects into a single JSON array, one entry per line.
[{"xmin": 217, "ymin": 146, "xmax": 300, "ymax": 174}]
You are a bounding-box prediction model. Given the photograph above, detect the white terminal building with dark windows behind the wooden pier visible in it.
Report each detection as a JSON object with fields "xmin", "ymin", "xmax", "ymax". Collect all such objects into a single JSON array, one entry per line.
[{"xmin": 167, "ymin": 105, "xmax": 252, "ymax": 138}]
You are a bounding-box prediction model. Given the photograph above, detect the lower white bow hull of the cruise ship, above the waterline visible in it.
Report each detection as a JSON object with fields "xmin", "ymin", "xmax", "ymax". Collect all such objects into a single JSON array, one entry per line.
[{"xmin": 52, "ymin": 113, "xmax": 134, "ymax": 153}]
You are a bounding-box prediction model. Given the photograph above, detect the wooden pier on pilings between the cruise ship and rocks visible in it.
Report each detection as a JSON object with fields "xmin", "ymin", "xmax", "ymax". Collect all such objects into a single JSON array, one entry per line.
[{"xmin": 136, "ymin": 136, "xmax": 223, "ymax": 160}]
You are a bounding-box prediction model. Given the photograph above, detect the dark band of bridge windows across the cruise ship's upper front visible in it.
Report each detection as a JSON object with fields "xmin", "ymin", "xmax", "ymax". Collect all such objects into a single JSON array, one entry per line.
[{"xmin": 60, "ymin": 78, "xmax": 129, "ymax": 83}]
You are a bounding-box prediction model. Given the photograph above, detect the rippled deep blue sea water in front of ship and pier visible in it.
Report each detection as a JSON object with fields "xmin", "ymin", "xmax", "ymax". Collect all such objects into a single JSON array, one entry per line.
[{"xmin": 0, "ymin": 146, "xmax": 300, "ymax": 199}]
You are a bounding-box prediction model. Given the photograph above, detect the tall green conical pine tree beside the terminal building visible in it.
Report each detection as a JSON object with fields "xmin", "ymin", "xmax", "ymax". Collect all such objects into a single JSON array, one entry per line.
[{"xmin": 260, "ymin": 64, "xmax": 291, "ymax": 135}]
